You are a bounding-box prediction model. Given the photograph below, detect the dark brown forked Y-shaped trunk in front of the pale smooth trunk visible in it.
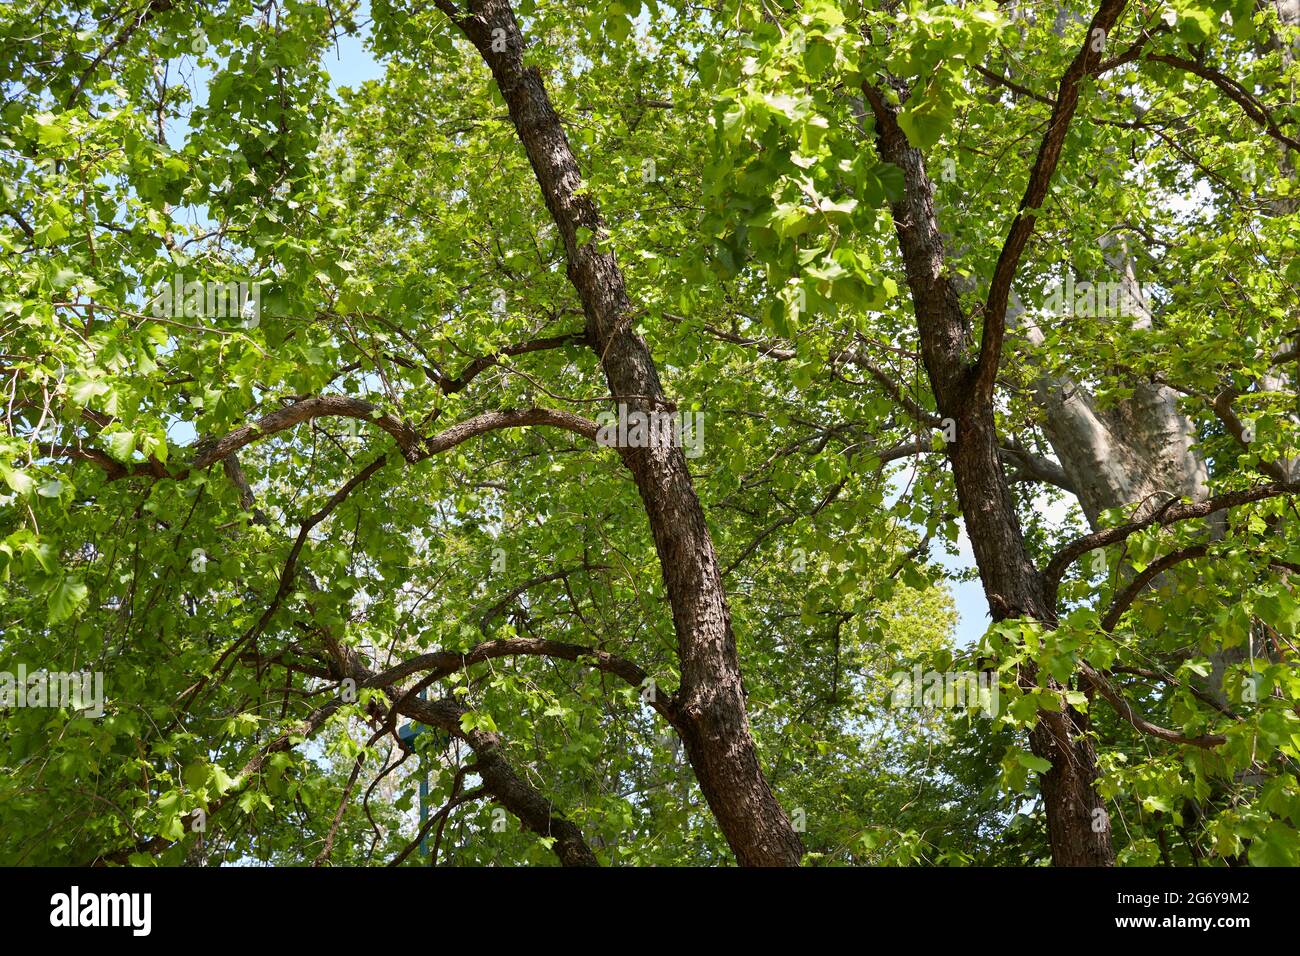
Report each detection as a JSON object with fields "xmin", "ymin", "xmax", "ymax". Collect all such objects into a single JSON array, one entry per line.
[{"xmin": 863, "ymin": 26, "xmax": 1123, "ymax": 866}]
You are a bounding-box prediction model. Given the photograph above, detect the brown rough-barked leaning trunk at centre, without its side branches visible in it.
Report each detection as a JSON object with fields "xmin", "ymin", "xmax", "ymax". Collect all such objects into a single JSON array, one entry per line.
[{"xmin": 438, "ymin": 0, "xmax": 803, "ymax": 866}]
